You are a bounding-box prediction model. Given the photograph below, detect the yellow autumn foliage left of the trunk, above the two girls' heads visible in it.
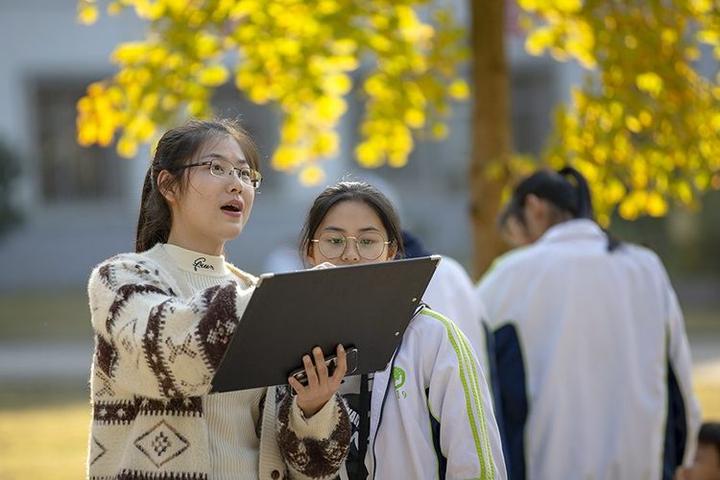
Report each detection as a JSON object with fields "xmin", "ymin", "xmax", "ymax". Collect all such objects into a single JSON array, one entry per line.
[{"xmin": 77, "ymin": 0, "xmax": 469, "ymax": 184}]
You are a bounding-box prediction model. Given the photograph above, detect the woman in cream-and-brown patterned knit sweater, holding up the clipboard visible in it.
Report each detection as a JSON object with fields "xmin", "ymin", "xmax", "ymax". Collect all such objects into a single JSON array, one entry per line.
[{"xmin": 88, "ymin": 120, "xmax": 350, "ymax": 480}]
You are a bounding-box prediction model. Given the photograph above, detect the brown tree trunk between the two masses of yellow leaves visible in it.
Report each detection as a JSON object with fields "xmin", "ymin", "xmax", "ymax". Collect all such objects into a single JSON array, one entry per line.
[{"xmin": 470, "ymin": 0, "xmax": 511, "ymax": 278}]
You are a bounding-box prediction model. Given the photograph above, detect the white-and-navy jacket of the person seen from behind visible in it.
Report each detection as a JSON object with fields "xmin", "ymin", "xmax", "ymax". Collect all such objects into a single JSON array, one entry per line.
[{"xmin": 478, "ymin": 220, "xmax": 699, "ymax": 480}]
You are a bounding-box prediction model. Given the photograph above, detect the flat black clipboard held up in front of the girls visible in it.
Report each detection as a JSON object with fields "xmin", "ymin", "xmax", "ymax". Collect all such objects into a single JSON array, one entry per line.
[{"xmin": 211, "ymin": 255, "xmax": 440, "ymax": 393}]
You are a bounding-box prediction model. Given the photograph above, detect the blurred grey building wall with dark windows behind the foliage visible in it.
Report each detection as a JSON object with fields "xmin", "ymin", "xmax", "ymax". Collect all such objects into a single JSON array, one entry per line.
[{"xmin": 0, "ymin": 0, "xmax": 578, "ymax": 293}]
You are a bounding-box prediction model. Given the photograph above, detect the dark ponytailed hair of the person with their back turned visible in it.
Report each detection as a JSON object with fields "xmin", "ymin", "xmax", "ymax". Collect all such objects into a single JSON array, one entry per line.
[{"xmin": 499, "ymin": 166, "xmax": 620, "ymax": 252}]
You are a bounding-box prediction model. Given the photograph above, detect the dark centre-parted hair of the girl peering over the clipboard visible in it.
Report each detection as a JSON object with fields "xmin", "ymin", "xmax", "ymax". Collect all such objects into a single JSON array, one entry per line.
[{"xmin": 300, "ymin": 181, "xmax": 405, "ymax": 258}]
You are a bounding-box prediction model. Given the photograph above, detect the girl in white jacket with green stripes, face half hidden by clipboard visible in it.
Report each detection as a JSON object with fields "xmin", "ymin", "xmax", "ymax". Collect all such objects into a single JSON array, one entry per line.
[{"xmin": 300, "ymin": 182, "xmax": 506, "ymax": 479}]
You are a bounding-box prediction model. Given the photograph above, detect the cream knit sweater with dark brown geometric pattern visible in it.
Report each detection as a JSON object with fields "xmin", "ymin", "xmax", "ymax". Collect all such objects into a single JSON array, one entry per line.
[{"xmin": 88, "ymin": 244, "xmax": 350, "ymax": 480}]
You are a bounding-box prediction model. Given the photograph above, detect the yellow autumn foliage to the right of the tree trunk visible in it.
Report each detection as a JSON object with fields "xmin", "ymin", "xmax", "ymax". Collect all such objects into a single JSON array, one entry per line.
[{"xmin": 519, "ymin": 0, "xmax": 720, "ymax": 222}]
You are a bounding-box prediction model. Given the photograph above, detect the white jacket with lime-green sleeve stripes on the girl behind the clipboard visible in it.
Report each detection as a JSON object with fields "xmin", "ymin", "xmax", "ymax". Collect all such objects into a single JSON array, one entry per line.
[{"xmin": 365, "ymin": 309, "xmax": 506, "ymax": 480}]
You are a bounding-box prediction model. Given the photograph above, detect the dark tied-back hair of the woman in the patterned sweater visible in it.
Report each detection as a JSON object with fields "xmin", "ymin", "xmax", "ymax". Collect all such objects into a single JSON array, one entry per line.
[{"xmin": 135, "ymin": 119, "xmax": 260, "ymax": 252}]
